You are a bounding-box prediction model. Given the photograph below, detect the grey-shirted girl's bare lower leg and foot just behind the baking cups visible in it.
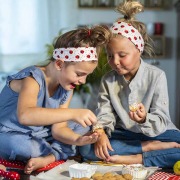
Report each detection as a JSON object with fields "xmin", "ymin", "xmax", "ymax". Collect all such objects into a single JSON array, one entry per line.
[{"xmin": 108, "ymin": 154, "xmax": 143, "ymax": 164}]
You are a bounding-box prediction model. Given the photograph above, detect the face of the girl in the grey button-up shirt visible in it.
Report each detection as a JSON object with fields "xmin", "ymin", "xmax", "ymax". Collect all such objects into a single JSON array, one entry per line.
[{"xmin": 107, "ymin": 36, "xmax": 141, "ymax": 80}]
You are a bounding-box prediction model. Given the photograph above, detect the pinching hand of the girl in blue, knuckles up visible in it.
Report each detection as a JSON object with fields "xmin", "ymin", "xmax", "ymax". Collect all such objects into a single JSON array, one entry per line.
[{"xmin": 73, "ymin": 109, "xmax": 97, "ymax": 127}]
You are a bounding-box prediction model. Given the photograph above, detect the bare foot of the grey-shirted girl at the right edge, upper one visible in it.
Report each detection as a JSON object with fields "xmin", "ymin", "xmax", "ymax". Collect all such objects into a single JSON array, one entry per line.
[{"xmin": 141, "ymin": 141, "xmax": 180, "ymax": 152}]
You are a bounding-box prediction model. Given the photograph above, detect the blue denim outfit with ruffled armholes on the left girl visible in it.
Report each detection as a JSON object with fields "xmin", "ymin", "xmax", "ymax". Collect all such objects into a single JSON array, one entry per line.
[{"xmin": 0, "ymin": 66, "xmax": 88, "ymax": 161}]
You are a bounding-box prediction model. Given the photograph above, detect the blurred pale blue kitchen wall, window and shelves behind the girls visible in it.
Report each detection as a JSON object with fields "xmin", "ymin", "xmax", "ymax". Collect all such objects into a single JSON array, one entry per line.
[{"xmin": 0, "ymin": 0, "xmax": 180, "ymax": 125}]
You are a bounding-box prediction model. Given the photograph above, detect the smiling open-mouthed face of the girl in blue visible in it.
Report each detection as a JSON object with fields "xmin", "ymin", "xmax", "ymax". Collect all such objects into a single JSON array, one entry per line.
[{"xmin": 58, "ymin": 62, "xmax": 97, "ymax": 90}]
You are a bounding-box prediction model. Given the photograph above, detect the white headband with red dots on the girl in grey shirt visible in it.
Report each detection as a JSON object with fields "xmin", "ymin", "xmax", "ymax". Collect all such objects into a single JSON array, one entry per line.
[{"xmin": 111, "ymin": 21, "xmax": 144, "ymax": 52}]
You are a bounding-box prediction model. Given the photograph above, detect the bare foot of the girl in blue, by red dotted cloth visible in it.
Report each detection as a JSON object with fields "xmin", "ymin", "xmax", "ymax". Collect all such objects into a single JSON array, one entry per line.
[{"xmin": 24, "ymin": 154, "xmax": 56, "ymax": 174}]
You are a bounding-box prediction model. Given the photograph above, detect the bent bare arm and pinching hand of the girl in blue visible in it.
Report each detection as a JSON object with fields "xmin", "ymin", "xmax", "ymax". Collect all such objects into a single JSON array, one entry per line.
[{"xmin": 17, "ymin": 77, "xmax": 97, "ymax": 127}]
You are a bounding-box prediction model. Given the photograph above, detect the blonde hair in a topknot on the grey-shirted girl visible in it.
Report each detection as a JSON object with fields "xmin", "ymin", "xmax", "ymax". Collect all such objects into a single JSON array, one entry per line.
[{"xmin": 115, "ymin": 0, "xmax": 154, "ymax": 57}]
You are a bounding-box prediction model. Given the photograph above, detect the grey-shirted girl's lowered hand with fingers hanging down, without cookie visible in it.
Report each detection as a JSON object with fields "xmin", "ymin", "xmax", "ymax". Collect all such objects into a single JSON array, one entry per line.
[{"xmin": 94, "ymin": 132, "xmax": 114, "ymax": 161}]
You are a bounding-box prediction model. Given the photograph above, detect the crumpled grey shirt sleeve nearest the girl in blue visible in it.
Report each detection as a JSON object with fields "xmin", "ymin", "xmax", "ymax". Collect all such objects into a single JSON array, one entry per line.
[{"xmin": 96, "ymin": 79, "xmax": 117, "ymax": 136}]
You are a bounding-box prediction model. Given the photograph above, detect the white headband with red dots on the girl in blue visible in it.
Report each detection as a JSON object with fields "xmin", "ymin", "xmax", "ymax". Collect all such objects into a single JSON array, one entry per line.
[{"xmin": 53, "ymin": 47, "xmax": 98, "ymax": 62}]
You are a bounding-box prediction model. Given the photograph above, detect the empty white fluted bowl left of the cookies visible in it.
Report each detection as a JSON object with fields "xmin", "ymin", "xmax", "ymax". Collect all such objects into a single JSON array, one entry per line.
[{"xmin": 69, "ymin": 164, "xmax": 97, "ymax": 178}]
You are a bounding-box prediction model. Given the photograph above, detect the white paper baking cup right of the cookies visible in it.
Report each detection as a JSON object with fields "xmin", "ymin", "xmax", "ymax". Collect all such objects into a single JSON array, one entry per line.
[{"xmin": 122, "ymin": 164, "xmax": 148, "ymax": 179}]
